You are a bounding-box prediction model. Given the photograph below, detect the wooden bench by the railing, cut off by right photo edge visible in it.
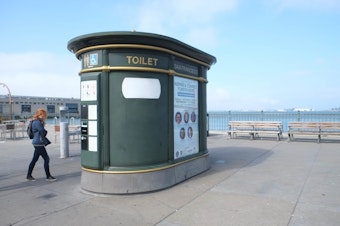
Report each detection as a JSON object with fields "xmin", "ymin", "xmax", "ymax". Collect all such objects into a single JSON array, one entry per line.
[{"xmin": 288, "ymin": 122, "xmax": 340, "ymax": 142}]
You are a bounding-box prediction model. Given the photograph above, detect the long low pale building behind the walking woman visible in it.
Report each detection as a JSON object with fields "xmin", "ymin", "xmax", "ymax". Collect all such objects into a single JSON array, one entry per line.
[{"xmin": 0, "ymin": 95, "xmax": 80, "ymax": 121}]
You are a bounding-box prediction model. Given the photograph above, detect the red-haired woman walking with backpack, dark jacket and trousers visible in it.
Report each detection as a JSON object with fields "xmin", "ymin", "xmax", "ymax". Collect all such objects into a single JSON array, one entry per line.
[{"xmin": 26, "ymin": 108, "xmax": 56, "ymax": 181}]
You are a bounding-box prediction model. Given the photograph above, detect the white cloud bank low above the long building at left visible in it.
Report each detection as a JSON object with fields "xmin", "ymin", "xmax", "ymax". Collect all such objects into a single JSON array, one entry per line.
[{"xmin": 0, "ymin": 52, "xmax": 80, "ymax": 98}]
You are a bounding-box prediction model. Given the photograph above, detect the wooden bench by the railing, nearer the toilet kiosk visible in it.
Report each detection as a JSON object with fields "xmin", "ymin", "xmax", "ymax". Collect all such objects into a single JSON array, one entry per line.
[{"xmin": 227, "ymin": 121, "xmax": 282, "ymax": 140}]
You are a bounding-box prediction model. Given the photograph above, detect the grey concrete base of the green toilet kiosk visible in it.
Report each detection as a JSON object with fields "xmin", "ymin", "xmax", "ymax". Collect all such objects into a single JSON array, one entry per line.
[{"xmin": 81, "ymin": 154, "xmax": 210, "ymax": 194}]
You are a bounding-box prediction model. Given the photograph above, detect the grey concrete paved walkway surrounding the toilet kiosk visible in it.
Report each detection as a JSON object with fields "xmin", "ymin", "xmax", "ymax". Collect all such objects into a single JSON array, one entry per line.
[{"xmin": 0, "ymin": 134, "xmax": 340, "ymax": 226}]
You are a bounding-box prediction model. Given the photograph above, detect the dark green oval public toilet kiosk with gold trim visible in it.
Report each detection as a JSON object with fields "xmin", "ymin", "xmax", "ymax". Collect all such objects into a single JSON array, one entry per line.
[{"xmin": 67, "ymin": 32, "xmax": 216, "ymax": 194}]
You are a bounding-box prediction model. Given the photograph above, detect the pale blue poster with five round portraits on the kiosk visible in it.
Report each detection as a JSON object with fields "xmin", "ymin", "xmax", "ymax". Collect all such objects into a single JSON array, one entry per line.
[{"xmin": 174, "ymin": 76, "xmax": 199, "ymax": 159}]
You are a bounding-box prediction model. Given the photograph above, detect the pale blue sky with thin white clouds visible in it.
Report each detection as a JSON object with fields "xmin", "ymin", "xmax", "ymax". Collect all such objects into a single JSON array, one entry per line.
[{"xmin": 0, "ymin": 0, "xmax": 340, "ymax": 111}]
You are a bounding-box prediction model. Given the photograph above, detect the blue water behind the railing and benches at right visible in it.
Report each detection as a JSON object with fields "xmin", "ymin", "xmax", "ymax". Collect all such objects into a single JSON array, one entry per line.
[{"xmin": 208, "ymin": 111, "xmax": 340, "ymax": 132}]
